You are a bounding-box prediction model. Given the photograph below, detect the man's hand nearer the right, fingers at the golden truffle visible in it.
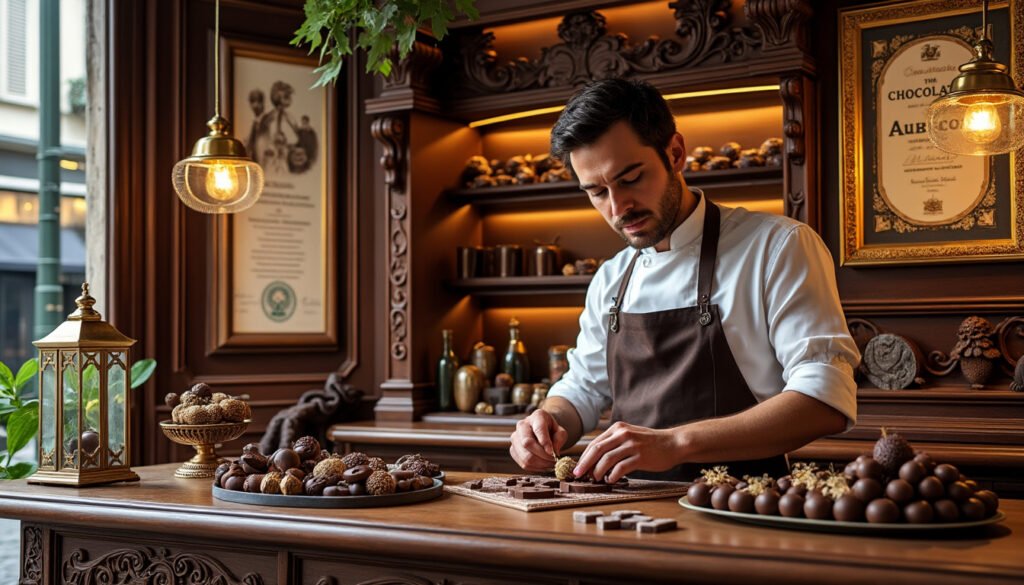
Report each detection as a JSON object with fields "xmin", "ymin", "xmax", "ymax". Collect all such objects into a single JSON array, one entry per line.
[{"xmin": 577, "ymin": 422, "xmax": 683, "ymax": 484}]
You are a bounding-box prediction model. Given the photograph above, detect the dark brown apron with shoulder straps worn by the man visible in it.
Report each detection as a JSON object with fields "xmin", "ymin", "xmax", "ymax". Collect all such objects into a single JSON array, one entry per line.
[{"xmin": 607, "ymin": 201, "xmax": 788, "ymax": 482}]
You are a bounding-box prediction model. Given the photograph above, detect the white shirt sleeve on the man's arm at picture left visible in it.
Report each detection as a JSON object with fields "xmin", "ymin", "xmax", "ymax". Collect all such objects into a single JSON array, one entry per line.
[{"xmin": 548, "ymin": 262, "xmax": 611, "ymax": 433}]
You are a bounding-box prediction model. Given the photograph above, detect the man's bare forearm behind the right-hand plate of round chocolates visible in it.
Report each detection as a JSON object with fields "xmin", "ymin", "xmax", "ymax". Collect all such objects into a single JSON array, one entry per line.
[{"xmin": 675, "ymin": 391, "xmax": 846, "ymax": 463}]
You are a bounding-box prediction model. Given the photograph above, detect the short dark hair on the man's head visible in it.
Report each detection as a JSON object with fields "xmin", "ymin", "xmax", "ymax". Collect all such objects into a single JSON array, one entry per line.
[{"xmin": 551, "ymin": 79, "xmax": 676, "ymax": 174}]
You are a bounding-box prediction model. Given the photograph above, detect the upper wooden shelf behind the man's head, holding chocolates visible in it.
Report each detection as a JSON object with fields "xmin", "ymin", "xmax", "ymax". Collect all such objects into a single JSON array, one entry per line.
[{"xmin": 447, "ymin": 167, "xmax": 782, "ymax": 207}]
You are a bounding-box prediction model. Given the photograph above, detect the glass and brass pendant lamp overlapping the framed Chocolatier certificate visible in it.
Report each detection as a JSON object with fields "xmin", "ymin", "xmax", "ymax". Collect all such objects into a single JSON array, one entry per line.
[{"xmin": 928, "ymin": 0, "xmax": 1024, "ymax": 156}]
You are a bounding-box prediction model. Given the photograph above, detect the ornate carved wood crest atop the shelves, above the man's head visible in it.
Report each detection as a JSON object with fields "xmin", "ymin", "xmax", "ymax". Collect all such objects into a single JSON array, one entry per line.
[{"xmin": 455, "ymin": 0, "xmax": 763, "ymax": 94}]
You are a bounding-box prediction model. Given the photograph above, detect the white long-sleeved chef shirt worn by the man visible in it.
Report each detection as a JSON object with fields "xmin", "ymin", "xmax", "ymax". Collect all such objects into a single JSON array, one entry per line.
[{"xmin": 548, "ymin": 187, "xmax": 860, "ymax": 432}]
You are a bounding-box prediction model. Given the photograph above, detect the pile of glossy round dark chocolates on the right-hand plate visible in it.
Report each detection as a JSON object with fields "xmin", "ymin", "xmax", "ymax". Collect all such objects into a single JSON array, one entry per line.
[{"xmin": 686, "ymin": 429, "xmax": 999, "ymax": 525}]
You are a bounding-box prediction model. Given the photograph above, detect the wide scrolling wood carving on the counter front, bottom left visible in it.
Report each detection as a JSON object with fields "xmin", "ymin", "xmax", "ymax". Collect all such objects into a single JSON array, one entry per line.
[{"xmin": 60, "ymin": 547, "xmax": 264, "ymax": 585}]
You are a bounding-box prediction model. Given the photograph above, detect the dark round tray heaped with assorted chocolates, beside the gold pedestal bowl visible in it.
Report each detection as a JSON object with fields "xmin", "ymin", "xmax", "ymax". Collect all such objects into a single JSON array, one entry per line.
[{"xmin": 213, "ymin": 436, "xmax": 444, "ymax": 508}]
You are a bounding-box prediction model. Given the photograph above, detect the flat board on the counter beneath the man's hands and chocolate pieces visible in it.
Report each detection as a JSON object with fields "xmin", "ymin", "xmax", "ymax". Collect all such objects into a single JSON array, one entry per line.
[{"xmin": 444, "ymin": 475, "xmax": 689, "ymax": 512}]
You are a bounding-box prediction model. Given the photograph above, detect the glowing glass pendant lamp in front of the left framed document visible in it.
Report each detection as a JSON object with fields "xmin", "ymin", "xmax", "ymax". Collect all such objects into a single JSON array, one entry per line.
[{"xmin": 171, "ymin": 0, "xmax": 263, "ymax": 213}]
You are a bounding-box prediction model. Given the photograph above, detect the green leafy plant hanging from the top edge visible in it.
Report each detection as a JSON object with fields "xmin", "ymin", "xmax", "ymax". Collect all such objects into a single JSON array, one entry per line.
[{"xmin": 292, "ymin": 0, "xmax": 479, "ymax": 87}]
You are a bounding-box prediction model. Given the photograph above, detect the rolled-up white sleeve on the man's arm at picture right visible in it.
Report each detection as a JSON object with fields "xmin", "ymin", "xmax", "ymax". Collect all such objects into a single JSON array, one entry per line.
[{"xmin": 764, "ymin": 225, "xmax": 860, "ymax": 429}]
